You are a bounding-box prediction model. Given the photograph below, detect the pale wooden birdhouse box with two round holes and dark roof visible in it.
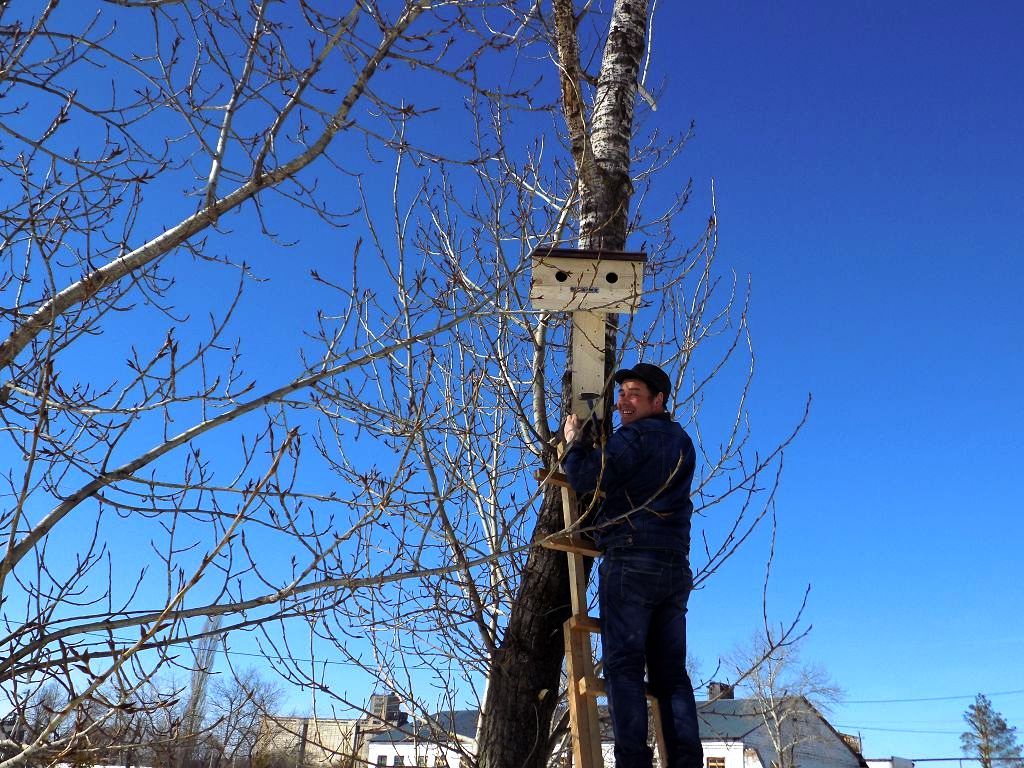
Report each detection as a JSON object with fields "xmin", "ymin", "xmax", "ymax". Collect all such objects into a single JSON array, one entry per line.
[{"xmin": 529, "ymin": 246, "xmax": 647, "ymax": 314}]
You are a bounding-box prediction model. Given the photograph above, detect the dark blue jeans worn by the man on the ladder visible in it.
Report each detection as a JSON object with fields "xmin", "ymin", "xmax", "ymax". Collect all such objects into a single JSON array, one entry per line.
[{"xmin": 598, "ymin": 547, "xmax": 703, "ymax": 768}]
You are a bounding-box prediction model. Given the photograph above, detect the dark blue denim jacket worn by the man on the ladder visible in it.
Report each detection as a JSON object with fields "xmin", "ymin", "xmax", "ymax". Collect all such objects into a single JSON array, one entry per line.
[{"xmin": 562, "ymin": 414, "xmax": 696, "ymax": 556}]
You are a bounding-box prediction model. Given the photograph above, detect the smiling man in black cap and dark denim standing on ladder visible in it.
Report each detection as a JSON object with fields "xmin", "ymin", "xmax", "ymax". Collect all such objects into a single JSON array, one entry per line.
[{"xmin": 562, "ymin": 362, "xmax": 703, "ymax": 768}]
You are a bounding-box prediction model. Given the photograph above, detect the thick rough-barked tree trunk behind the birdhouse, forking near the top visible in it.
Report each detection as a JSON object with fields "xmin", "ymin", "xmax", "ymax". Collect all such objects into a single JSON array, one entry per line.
[{"xmin": 477, "ymin": 0, "xmax": 647, "ymax": 768}]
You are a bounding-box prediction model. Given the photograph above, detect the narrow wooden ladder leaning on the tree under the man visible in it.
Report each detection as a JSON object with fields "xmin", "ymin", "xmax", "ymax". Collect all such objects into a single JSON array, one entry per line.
[{"xmin": 537, "ymin": 471, "xmax": 667, "ymax": 768}]
